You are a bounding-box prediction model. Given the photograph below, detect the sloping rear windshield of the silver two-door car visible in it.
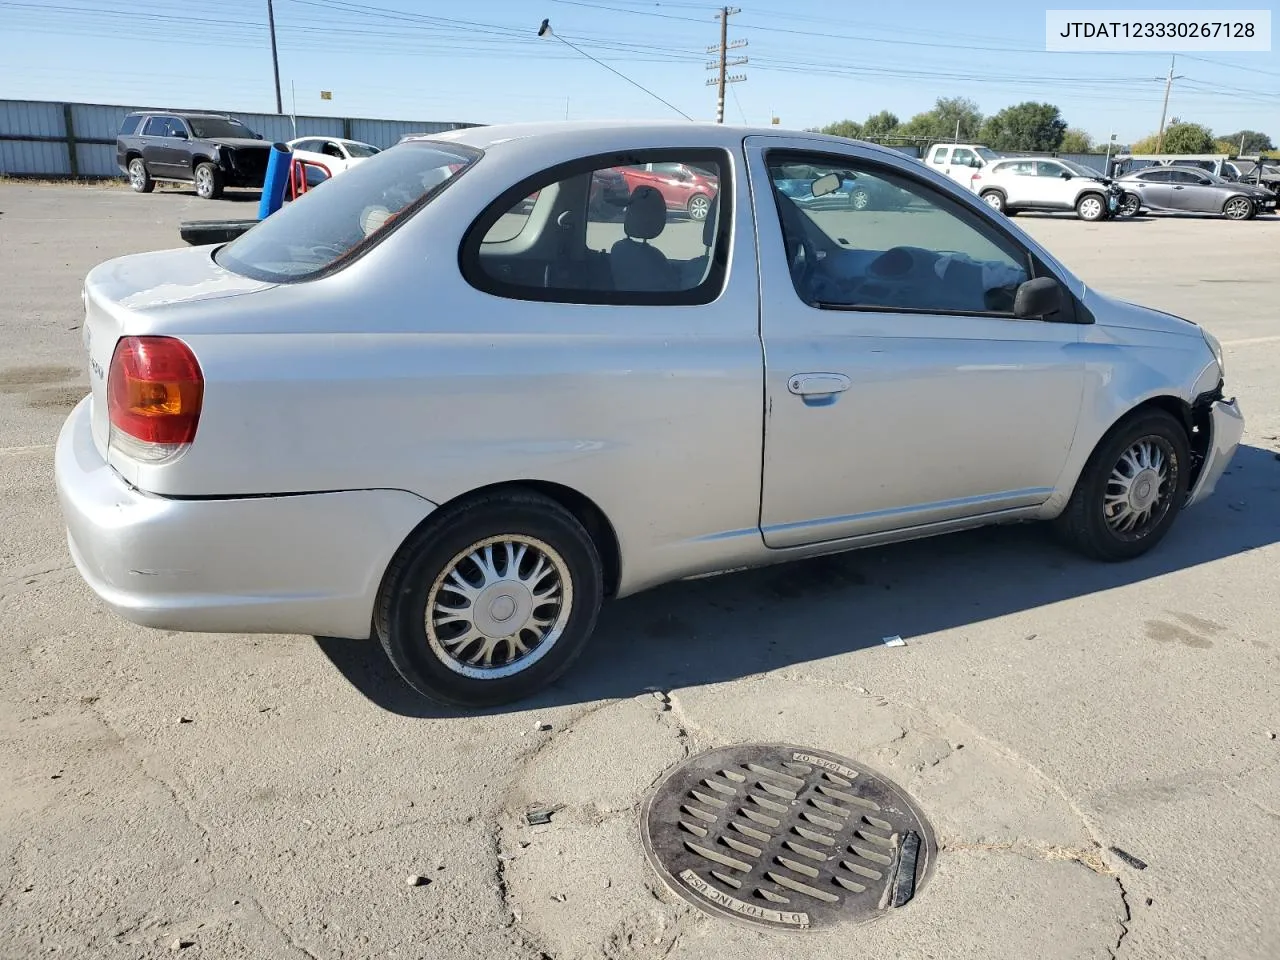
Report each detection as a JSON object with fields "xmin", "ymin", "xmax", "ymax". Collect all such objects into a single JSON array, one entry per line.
[{"xmin": 214, "ymin": 141, "xmax": 480, "ymax": 283}]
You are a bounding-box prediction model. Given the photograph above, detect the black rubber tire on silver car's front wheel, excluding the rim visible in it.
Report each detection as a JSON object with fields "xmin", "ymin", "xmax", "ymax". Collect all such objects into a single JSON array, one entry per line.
[{"xmin": 1053, "ymin": 410, "xmax": 1190, "ymax": 561}]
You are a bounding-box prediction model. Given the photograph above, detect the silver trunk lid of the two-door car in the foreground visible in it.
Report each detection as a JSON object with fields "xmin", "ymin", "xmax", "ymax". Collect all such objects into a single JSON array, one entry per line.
[{"xmin": 81, "ymin": 247, "xmax": 274, "ymax": 460}]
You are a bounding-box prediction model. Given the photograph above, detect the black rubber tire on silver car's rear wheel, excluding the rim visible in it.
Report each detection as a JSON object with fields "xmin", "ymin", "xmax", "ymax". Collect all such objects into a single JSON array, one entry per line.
[{"xmin": 374, "ymin": 490, "xmax": 604, "ymax": 707}]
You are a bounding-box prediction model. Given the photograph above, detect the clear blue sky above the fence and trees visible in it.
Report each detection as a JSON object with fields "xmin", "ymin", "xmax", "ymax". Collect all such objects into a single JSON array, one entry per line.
[{"xmin": 0, "ymin": 0, "xmax": 1280, "ymax": 142}]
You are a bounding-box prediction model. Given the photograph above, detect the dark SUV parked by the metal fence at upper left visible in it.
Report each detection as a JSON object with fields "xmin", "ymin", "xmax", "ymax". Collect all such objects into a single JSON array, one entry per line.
[{"xmin": 115, "ymin": 110, "xmax": 271, "ymax": 200}]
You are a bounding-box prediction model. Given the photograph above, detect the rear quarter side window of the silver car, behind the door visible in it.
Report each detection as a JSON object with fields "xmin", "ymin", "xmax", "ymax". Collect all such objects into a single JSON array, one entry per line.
[{"xmin": 462, "ymin": 150, "xmax": 730, "ymax": 305}]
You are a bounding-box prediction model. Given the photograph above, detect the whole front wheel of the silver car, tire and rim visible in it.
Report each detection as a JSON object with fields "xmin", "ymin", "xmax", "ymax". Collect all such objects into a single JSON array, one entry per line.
[{"xmin": 1053, "ymin": 410, "xmax": 1190, "ymax": 561}]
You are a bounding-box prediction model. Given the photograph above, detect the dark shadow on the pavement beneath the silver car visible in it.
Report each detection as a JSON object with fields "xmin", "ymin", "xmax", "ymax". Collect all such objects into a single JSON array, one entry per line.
[{"xmin": 317, "ymin": 445, "xmax": 1280, "ymax": 718}]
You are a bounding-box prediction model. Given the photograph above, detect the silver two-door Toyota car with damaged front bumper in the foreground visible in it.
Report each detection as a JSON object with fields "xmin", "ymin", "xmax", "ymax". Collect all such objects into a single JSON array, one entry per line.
[{"xmin": 55, "ymin": 123, "xmax": 1243, "ymax": 707}]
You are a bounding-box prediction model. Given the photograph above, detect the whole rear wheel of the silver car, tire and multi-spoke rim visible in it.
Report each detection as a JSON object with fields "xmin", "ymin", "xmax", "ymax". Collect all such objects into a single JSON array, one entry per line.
[{"xmin": 375, "ymin": 492, "xmax": 604, "ymax": 707}]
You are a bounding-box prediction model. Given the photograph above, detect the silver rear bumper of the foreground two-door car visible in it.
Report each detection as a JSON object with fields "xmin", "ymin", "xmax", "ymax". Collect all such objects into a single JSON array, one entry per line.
[{"xmin": 54, "ymin": 399, "xmax": 435, "ymax": 639}]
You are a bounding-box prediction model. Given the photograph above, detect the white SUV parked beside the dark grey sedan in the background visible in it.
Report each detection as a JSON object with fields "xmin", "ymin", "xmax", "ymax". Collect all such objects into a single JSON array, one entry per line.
[{"xmin": 973, "ymin": 156, "xmax": 1120, "ymax": 220}]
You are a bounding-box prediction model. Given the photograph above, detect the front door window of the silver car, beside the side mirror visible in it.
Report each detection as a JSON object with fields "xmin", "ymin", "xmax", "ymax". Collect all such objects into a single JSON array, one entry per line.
[{"xmin": 765, "ymin": 152, "xmax": 1032, "ymax": 316}]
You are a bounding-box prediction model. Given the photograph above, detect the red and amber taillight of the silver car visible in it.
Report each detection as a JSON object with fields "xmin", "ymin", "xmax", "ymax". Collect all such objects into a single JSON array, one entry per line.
[{"xmin": 106, "ymin": 337, "xmax": 205, "ymax": 462}]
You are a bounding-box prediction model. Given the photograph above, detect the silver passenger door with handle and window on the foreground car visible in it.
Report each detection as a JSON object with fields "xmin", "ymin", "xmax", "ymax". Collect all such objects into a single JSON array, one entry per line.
[{"xmin": 746, "ymin": 137, "xmax": 1084, "ymax": 548}]
